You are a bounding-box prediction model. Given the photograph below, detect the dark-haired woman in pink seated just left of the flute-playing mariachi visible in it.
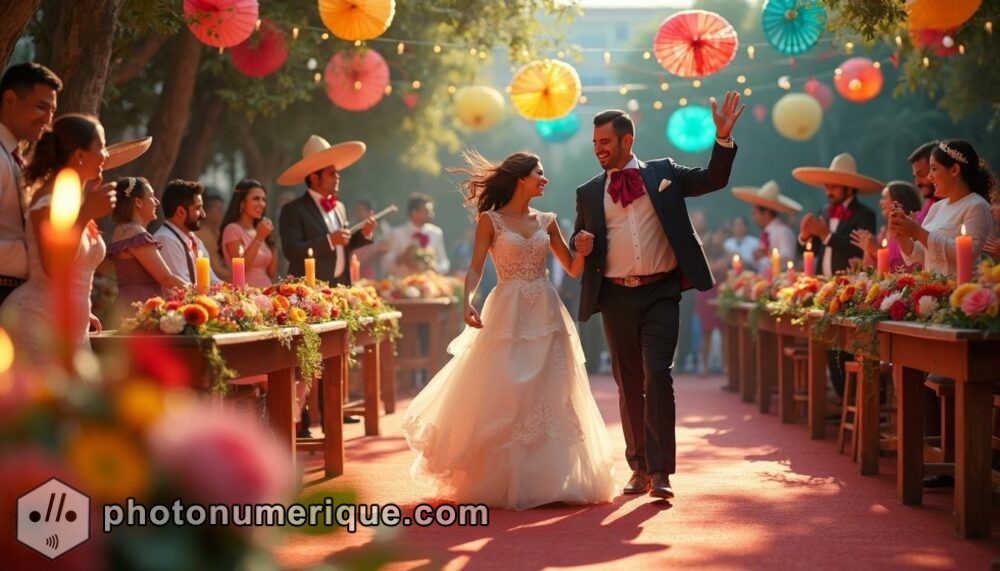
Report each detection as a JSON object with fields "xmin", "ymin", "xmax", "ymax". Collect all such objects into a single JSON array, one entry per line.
[{"xmin": 219, "ymin": 179, "xmax": 278, "ymax": 288}]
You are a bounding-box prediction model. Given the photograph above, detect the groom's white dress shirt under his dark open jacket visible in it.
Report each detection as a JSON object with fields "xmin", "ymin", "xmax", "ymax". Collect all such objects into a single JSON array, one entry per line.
[{"xmin": 604, "ymin": 155, "xmax": 677, "ymax": 278}]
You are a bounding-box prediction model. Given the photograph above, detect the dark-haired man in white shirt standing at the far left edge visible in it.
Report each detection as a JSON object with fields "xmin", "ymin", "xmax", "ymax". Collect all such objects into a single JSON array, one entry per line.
[{"xmin": 0, "ymin": 63, "xmax": 62, "ymax": 304}]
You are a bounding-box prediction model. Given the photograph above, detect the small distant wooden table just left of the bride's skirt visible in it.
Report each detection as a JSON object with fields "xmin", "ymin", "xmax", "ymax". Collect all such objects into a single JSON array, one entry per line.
[{"xmin": 389, "ymin": 297, "xmax": 458, "ymax": 380}]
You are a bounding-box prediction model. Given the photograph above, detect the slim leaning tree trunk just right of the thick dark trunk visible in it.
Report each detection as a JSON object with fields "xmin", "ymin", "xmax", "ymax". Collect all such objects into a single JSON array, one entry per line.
[{"xmin": 129, "ymin": 28, "xmax": 202, "ymax": 193}]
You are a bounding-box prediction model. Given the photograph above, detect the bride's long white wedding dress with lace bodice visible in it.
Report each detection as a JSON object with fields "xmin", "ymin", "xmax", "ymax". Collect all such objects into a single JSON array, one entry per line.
[{"xmin": 403, "ymin": 212, "xmax": 615, "ymax": 510}]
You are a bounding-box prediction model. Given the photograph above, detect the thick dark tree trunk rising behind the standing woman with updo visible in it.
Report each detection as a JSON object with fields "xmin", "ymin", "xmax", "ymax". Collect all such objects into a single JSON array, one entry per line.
[{"xmin": 52, "ymin": 0, "xmax": 124, "ymax": 115}]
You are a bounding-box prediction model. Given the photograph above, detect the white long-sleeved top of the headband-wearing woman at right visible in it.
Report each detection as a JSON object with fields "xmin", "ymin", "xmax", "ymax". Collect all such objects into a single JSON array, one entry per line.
[{"xmin": 903, "ymin": 192, "xmax": 993, "ymax": 276}]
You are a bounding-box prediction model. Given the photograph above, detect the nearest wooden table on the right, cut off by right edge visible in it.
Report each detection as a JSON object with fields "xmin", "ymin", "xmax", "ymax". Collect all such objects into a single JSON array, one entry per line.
[{"xmin": 878, "ymin": 321, "xmax": 1000, "ymax": 538}]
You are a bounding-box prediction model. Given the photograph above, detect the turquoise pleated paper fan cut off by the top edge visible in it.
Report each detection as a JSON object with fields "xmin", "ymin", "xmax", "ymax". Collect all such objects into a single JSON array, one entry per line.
[{"xmin": 761, "ymin": 0, "xmax": 826, "ymax": 55}]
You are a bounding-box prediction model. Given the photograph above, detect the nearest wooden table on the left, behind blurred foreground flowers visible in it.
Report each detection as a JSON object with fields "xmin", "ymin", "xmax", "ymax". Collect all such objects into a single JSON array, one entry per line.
[{"xmin": 90, "ymin": 321, "xmax": 348, "ymax": 477}]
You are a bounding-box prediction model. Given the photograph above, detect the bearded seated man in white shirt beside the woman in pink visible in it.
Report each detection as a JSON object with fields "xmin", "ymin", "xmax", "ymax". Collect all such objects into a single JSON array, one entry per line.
[{"xmin": 153, "ymin": 180, "xmax": 219, "ymax": 284}]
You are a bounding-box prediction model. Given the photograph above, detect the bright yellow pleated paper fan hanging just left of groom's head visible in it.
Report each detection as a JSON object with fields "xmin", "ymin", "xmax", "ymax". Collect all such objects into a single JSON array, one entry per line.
[{"xmin": 510, "ymin": 60, "xmax": 580, "ymax": 120}]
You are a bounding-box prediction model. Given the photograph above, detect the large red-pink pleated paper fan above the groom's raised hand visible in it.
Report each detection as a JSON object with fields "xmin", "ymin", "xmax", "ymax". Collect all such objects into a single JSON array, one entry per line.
[{"xmin": 653, "ymin": 10, "xmax": 739, "ymax": 77}]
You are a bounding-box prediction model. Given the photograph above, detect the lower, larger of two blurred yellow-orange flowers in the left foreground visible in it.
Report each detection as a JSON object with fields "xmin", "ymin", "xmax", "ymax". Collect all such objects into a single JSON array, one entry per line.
[{"xmin": 66, "ymin": 427, "xmax": 149, "ymax": 503}]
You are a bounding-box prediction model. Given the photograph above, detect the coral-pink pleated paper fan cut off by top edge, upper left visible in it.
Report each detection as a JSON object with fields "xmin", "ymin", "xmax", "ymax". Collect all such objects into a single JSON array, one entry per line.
[{"xmin": 184, "ymin": 0, "xmax": 258, "ymax": 48}]
